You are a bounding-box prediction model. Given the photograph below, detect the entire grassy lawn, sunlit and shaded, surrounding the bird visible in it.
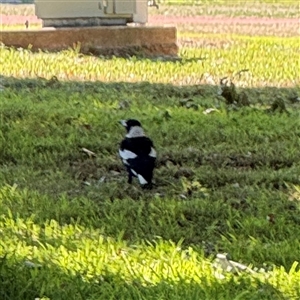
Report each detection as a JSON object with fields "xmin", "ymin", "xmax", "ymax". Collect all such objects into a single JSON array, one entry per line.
[{"xmin": 0, "ymin": 1, "xmax": 300, "ymax": 300}]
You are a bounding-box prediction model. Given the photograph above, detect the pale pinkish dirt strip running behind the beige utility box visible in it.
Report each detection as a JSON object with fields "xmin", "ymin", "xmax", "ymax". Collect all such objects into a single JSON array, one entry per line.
[{"xmin": 0, "ymin": 14, "xmax": 300, "ymax": 36}]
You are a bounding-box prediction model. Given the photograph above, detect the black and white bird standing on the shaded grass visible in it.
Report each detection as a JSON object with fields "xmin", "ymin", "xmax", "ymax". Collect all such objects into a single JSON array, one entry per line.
[{"xmin": 119, "ymin": 119, "xmax": 156, "ymax": 188}]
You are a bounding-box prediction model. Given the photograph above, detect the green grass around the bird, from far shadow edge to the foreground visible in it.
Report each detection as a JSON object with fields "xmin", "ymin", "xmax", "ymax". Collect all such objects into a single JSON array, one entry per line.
[{"xmin": 0, "ymin": 74, "xmax": 300, "ymax": 299}]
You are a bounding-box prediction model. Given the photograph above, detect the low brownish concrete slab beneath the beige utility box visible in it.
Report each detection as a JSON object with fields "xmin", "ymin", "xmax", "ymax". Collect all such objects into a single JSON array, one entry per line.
[{"xmin": 0, "ymin": 26, "xmax": 178, "ymax": 56}]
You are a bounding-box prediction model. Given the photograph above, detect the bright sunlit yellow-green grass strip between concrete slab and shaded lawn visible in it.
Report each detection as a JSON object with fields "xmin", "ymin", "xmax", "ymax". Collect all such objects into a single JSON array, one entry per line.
[{"xmin": 0, "ymin": 34, "xmax": 299, "ymax": 87}]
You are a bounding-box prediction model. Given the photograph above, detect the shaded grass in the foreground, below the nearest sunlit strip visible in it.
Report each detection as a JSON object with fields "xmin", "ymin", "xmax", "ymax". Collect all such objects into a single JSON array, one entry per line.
[{"xmin": 0, "ymin": 253, "xmax": 286, "ymax": 300}]
